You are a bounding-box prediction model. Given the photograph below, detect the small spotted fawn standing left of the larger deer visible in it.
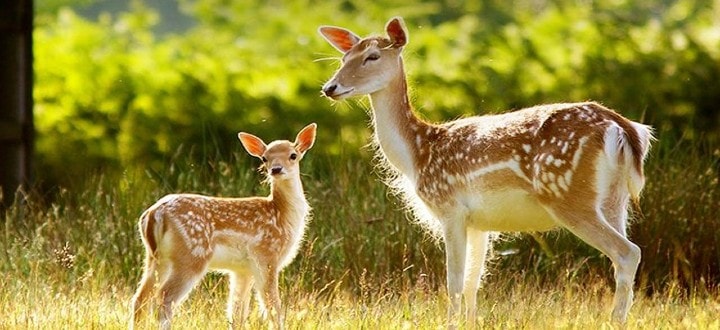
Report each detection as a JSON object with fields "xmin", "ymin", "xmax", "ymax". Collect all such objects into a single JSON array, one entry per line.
[{"xmin": 130, "ymin": 124, "xmax": 316, "ymax": 328}]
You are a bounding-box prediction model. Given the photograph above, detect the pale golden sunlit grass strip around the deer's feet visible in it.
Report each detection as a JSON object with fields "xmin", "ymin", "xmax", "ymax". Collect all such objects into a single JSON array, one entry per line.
[{"xmin": 0, "ymin": 279, "xmax": 720, "ymax": 329}]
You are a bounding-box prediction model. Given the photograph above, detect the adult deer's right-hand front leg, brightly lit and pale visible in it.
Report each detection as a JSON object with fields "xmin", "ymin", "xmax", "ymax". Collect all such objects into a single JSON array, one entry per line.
[{"xmin": 463, "ymin": 227, "xmax": 490, "ymax": 329}]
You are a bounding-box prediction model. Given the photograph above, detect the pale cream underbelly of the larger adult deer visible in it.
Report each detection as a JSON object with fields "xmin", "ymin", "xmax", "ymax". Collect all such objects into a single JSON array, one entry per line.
[{"xmin": 461, "ymin": 189, "xmax": 557, "ymax": 232}]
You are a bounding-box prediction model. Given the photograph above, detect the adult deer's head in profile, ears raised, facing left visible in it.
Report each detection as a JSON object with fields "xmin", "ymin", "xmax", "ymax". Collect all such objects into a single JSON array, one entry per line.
[{"xmin": 318, "ymin": 17, "xmax": 408, "ymax": 100}]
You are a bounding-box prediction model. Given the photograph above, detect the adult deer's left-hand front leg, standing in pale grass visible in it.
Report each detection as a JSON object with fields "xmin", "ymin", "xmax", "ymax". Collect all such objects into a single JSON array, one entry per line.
[{"xmin": 443, "ymin": 218, "xmax": 467, "ymax": 327}]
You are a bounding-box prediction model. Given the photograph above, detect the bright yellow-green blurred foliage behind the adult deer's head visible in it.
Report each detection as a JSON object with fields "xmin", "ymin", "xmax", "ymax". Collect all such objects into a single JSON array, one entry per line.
[{"xmin": 34, "ymin": 0, "xmax": 720, "ymax": 184}]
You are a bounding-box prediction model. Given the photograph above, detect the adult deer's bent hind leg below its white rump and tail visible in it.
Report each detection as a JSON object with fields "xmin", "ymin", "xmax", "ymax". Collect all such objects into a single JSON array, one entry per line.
[{"xmin": 552, "ymin": 206, "xmax": 640, "ymax": 323}]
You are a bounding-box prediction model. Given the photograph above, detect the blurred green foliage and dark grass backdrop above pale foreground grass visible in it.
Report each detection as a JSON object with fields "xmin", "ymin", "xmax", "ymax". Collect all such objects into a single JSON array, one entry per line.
[{"xmin": 0, "ymin": 0, "xmax": 720, "ymax": 300}]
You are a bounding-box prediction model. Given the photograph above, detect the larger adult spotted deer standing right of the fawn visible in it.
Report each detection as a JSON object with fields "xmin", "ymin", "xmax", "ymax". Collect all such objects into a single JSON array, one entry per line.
[{"xmin": 319, "ymin": 18, "xmax": 653, "ymax": 326}]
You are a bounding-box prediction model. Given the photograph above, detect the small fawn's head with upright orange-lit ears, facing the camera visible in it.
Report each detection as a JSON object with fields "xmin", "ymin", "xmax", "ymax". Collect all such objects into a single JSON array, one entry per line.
[{"xmin": 238, "ymin": 123, "xmax": 317, "ymax": 180}]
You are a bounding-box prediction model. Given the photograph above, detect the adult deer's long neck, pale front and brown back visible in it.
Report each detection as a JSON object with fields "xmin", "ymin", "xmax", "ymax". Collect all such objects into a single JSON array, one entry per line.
[{"xmin": 370, "ymin": 57, "xmax": 430, "ymax": 180}]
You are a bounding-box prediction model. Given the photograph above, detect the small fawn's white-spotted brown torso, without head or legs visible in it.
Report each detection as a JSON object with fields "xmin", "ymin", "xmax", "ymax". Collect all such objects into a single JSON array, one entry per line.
[{"xmin": 140, "ymin": 194, "xmax": 309, "ymax": 270}]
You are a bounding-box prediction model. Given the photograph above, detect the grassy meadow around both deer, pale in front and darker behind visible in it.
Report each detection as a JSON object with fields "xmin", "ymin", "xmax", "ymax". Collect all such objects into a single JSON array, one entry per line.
[{"xmin": 0, "ymin": 138, "xmax": 720, "ymax": 329}]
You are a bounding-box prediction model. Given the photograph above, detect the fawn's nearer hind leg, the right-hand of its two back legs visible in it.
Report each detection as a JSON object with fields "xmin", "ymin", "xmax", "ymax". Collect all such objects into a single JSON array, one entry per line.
[{"xmin": 155, "ymin": 262, "xmax": 206, "ymax": 329}]
